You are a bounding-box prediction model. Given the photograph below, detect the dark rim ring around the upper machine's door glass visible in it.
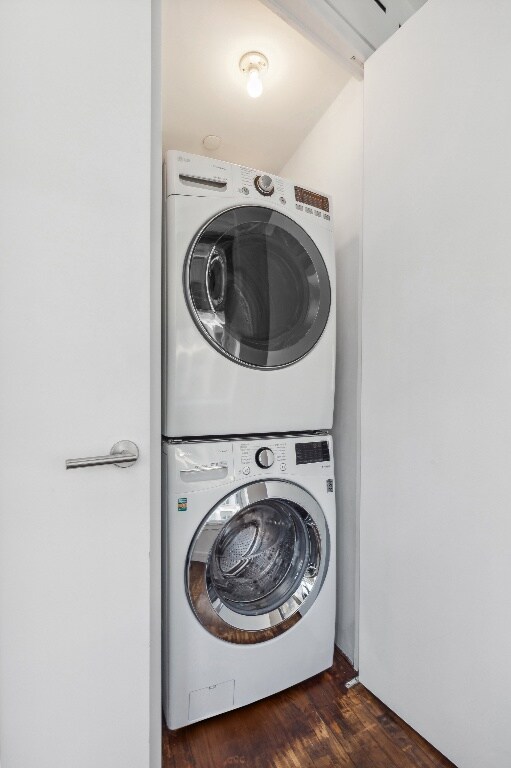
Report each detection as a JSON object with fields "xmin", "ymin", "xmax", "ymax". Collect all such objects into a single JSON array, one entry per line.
[{"xmin": 183, "ymin": 203, "xmax": 332, "ymax": 371}]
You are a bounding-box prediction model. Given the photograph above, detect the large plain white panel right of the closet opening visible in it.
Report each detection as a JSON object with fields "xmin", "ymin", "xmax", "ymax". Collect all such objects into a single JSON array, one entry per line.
[{"xmin": 360, "ymin": 0, "xmax": 511, "ymax": 768}]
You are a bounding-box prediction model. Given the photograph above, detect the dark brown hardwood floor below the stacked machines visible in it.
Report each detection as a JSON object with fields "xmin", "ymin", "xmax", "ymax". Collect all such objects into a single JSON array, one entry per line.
[{"xmin": 163, "ymin": 652, "xmax": 455, "ymax": 768}]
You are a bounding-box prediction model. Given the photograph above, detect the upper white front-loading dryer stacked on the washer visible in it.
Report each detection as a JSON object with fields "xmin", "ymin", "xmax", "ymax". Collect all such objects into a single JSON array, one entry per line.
[{"xmin": 162, "ymin": 151, "xmax": 335, "ymax": 437}]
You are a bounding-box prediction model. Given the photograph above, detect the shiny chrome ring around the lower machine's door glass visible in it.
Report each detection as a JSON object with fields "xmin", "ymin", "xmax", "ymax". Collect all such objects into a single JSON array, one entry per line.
[{"xmin": 186, "ymin": 480, "xmax": 330, "ymax": 642}]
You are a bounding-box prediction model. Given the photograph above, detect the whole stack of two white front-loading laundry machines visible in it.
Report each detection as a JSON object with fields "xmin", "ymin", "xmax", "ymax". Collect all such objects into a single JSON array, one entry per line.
[{"xmin": 163, "ymin": 151, "xmax": 336, "ymax": 729}]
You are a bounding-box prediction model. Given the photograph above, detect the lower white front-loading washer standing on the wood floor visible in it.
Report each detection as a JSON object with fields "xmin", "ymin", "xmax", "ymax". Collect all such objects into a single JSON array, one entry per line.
[{"xmin": 163, "ymin": 435, "xmax": 335, "ymax": 729}]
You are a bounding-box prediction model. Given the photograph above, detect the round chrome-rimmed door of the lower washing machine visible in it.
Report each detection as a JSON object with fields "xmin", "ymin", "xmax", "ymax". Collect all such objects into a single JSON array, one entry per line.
[{"xmin": 186, "ymin": 480, "xmax": 329, "ymax": 643}]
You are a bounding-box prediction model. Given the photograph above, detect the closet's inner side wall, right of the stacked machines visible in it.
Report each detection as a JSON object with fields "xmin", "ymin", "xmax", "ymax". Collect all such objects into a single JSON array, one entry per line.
[{"xmin": 281, "ymin": 79, "xmax": 363, "ymax": 663}]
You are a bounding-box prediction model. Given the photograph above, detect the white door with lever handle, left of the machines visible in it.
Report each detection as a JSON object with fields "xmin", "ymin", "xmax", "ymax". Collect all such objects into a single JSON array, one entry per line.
[{"xmin": 0, "ymin": 0, "xmax": 160, "ymax": 768}]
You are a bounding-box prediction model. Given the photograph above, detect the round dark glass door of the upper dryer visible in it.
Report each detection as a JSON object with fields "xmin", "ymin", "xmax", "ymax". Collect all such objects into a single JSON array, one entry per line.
[{"xmin": 184, "ymin": 205, "xmax": 331, "ymax": 369}]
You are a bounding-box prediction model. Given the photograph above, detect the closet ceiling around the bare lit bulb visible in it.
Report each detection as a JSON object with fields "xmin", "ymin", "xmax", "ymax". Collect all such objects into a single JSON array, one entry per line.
[{"xmin": 162, "ymin": 0, "xmax": 350, "ymax": 173}]
